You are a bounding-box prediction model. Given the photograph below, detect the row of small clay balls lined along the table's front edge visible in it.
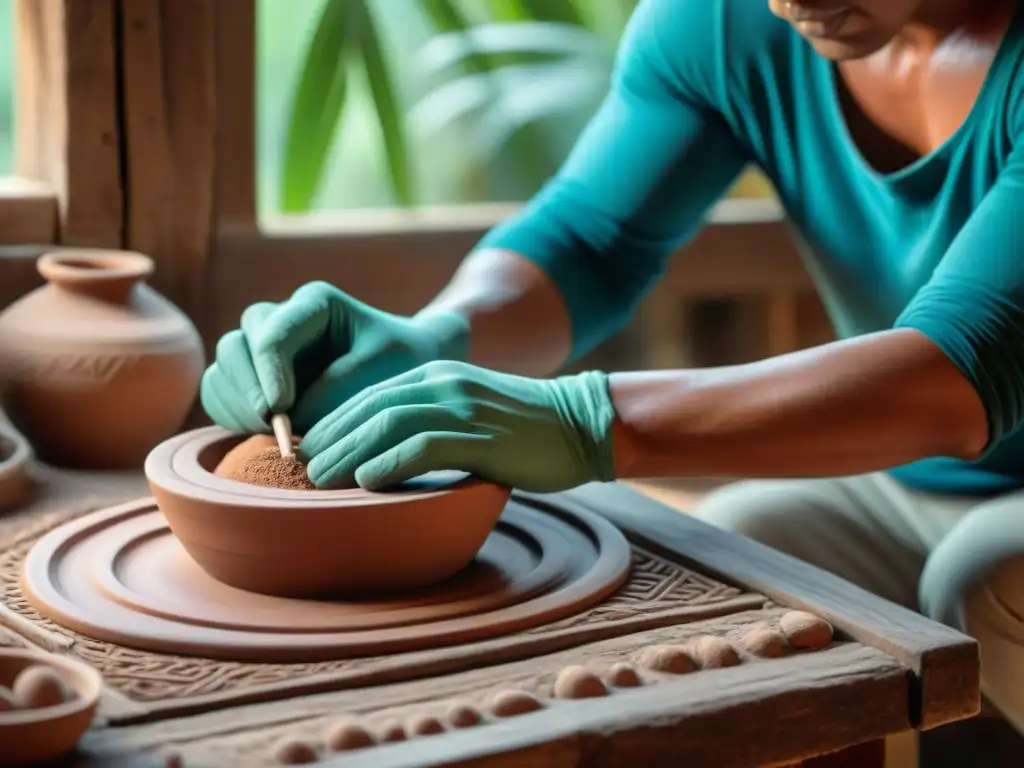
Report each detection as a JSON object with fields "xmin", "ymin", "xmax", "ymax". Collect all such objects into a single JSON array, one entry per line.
[{"xmin": 273, "ymin": 611, "xmax": 833, "ymax": 765}]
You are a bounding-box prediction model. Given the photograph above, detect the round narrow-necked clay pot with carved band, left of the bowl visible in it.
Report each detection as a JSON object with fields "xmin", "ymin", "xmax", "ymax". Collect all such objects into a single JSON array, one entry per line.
[{"xmin": 0, "ymin": 249, "xmax": 205, "ymax": 469}]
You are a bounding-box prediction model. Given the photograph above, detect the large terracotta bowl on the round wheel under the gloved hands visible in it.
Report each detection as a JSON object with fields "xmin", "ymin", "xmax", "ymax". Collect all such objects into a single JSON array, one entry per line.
[{"xmin": 145, "ymin": 427, "xmax": 511, "ymax": 597}]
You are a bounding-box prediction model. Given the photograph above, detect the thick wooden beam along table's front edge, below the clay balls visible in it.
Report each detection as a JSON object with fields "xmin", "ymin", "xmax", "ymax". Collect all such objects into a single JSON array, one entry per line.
[{"xmin": 318, "ymin": 644, "xmax": 909, "ymax": 768}]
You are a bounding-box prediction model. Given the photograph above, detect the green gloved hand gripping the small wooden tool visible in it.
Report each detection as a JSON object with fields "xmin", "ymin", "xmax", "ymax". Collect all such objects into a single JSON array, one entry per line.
[{"xmin": 200, "ymin": 283, "xmax": 468, "ymax": 434}]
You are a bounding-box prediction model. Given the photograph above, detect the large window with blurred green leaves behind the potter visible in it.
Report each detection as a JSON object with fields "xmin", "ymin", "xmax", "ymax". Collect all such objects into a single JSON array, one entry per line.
[{"xmin": 257, "ymin": 0, "xmax": 768, "ymax": 215}]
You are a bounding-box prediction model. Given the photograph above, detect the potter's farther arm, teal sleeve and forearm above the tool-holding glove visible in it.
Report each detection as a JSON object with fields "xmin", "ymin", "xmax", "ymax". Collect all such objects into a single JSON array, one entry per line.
[{"xmin": 415, "ymin": 0, "xmax": 748, "ymax": 376}]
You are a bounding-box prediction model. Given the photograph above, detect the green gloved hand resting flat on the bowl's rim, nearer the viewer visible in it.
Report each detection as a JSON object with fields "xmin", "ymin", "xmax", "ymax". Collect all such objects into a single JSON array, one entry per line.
[{"xmin": 299, "ymin": 362, "xmax": 615, "ymax": 493}]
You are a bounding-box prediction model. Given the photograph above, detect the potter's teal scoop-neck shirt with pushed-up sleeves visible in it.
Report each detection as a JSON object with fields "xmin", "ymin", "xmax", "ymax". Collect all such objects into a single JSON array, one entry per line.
[{"xmin": 480, "ymin": 0, "xmax": 1024, "ymax": 495}]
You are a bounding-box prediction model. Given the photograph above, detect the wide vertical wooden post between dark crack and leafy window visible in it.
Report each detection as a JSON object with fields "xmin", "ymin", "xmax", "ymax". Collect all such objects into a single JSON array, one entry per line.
[{"xmin": 118, "ymin": 0, "xmax": 218, "ymax": 337}]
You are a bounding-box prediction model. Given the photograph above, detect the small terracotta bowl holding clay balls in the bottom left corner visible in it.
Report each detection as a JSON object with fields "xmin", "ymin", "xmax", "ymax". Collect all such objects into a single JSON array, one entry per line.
[{"xmin": 0, "ymin": 648, "xmax": 103, "ymax": 766}]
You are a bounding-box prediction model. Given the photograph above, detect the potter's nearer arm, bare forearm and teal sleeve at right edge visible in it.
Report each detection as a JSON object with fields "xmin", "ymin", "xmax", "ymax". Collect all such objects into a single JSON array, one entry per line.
[{"xmin": 611, "ymin": 145, "xmax": 1024, "ymax": 477}]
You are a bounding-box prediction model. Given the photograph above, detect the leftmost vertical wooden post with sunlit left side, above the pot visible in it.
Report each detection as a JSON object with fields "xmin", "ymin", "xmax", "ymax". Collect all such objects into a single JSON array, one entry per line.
[{"xmin": 14, "ymin": 0, "xmax": 123, "ymax": 248}]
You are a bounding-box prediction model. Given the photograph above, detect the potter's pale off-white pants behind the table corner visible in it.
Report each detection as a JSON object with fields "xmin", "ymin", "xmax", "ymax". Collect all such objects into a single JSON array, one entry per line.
[{"xmin": 696, "ymin": 473, "xmax": 1024, "ymax": 733}]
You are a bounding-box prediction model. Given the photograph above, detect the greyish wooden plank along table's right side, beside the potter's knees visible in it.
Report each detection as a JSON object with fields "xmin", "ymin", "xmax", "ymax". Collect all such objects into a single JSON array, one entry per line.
[{"xmin": 544, "ymin": 483, "xmax": 981, "ymax": 730}]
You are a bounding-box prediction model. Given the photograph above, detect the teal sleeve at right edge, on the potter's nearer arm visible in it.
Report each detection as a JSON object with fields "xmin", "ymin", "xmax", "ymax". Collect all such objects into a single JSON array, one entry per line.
[{"xmin": 896, "ymin": 145, "xmax": 1024, "ymax": 453}]
